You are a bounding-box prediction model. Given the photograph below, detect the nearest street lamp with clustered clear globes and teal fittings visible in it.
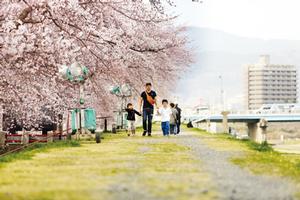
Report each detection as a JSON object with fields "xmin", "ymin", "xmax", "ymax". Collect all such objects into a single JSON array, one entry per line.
[{"xmin": 58, "ymin": 62, "xmax": 89, "ymax": 138}]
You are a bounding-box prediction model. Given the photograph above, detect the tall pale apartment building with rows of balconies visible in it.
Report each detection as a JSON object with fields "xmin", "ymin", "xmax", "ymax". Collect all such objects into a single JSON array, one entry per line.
[{"xmin": 246, "ymin": 55, "xmax": 298, "ymax": 110}]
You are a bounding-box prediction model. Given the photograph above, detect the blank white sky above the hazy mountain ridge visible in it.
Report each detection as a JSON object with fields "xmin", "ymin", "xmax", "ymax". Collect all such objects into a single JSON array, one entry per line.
[{"xmin": 174, "ymin": 0, "xmax": 300, "ymax": 40}]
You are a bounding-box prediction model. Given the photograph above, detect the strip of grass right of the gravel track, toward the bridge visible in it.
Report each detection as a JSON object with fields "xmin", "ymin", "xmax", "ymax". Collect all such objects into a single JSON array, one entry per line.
[{"xmin": 192, "ymin": 129, "xmax": 300, "ymax": 183}]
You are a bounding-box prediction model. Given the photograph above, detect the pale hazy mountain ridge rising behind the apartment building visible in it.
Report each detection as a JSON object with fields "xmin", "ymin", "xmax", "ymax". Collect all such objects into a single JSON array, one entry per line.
[{"xmin": 177, "ymin": 26, "xmax": 300, "ymax": 106}]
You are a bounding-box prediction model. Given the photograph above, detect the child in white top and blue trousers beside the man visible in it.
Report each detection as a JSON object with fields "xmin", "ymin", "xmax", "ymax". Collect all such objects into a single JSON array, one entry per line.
[{"xmin": 158, "ymin": 99, "xmax": 171, "ymax": 136}]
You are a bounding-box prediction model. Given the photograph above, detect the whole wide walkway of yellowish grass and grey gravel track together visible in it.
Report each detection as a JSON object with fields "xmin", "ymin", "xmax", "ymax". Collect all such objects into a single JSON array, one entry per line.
[{"xmin": 0, "ymin": 132, "xmax": 294, "ymax": 200}]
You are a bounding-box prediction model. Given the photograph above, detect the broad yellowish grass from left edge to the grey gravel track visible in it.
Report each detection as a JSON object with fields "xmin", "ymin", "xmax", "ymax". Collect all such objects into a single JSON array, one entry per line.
[{"xmin": 0, "ymin": 130, "xmax": 217, "ymax": 200}]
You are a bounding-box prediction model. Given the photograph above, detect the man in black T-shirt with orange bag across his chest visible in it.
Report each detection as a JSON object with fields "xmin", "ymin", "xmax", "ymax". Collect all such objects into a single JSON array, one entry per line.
[{"xmin": 139, "ymin": 83, "xmax": 157, "ymax": 136}]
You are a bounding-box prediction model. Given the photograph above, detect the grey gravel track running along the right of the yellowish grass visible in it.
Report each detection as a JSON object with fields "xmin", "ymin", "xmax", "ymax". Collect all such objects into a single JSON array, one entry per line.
[{"xmin": 175, "ymin": 133, "xmax": 295, "ymax": 200}]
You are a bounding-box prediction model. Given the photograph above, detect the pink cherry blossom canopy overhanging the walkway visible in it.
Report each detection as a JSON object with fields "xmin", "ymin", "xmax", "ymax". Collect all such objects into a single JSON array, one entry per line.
[{"xmin": 0, "ymin": 0, "xmax": 191, "ymax": 127}]
